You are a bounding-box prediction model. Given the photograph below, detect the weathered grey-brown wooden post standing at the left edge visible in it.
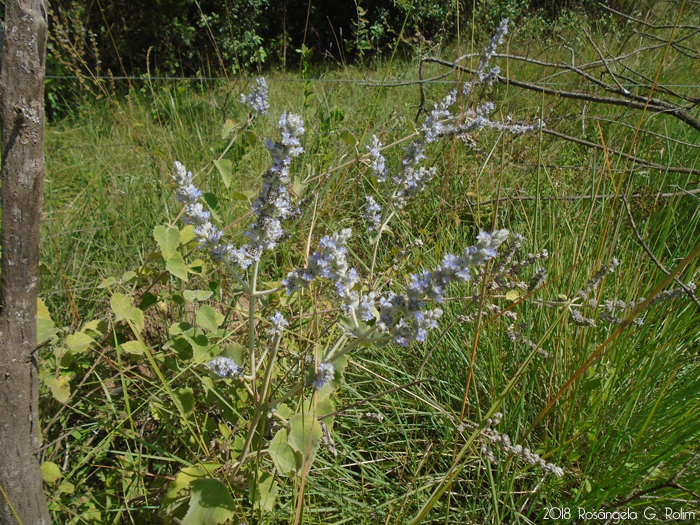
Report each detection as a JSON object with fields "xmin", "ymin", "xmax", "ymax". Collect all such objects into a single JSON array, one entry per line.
[{"xmin": 0, "ymin": 0, "xmax": 51, "ymax": 525}]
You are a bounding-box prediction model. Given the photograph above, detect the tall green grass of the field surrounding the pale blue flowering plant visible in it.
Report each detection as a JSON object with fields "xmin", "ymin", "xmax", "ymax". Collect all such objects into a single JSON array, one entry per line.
[{"xmin": 41, "ymin": 6, "xmax": 700, "ymax": 524}]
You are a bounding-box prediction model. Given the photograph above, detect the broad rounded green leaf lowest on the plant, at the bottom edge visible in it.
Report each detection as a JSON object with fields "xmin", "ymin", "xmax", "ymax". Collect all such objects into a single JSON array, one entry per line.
[{"xmin": 182, "ymin": 479, "xmax": 236, "ymax": 525}]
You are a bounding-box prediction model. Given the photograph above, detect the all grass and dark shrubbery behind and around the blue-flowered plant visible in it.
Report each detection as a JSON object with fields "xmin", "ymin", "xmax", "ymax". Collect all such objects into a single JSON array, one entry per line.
[{"xmin": 28, "ymin": 0, "xmax": 700, "ymax": 524}]
